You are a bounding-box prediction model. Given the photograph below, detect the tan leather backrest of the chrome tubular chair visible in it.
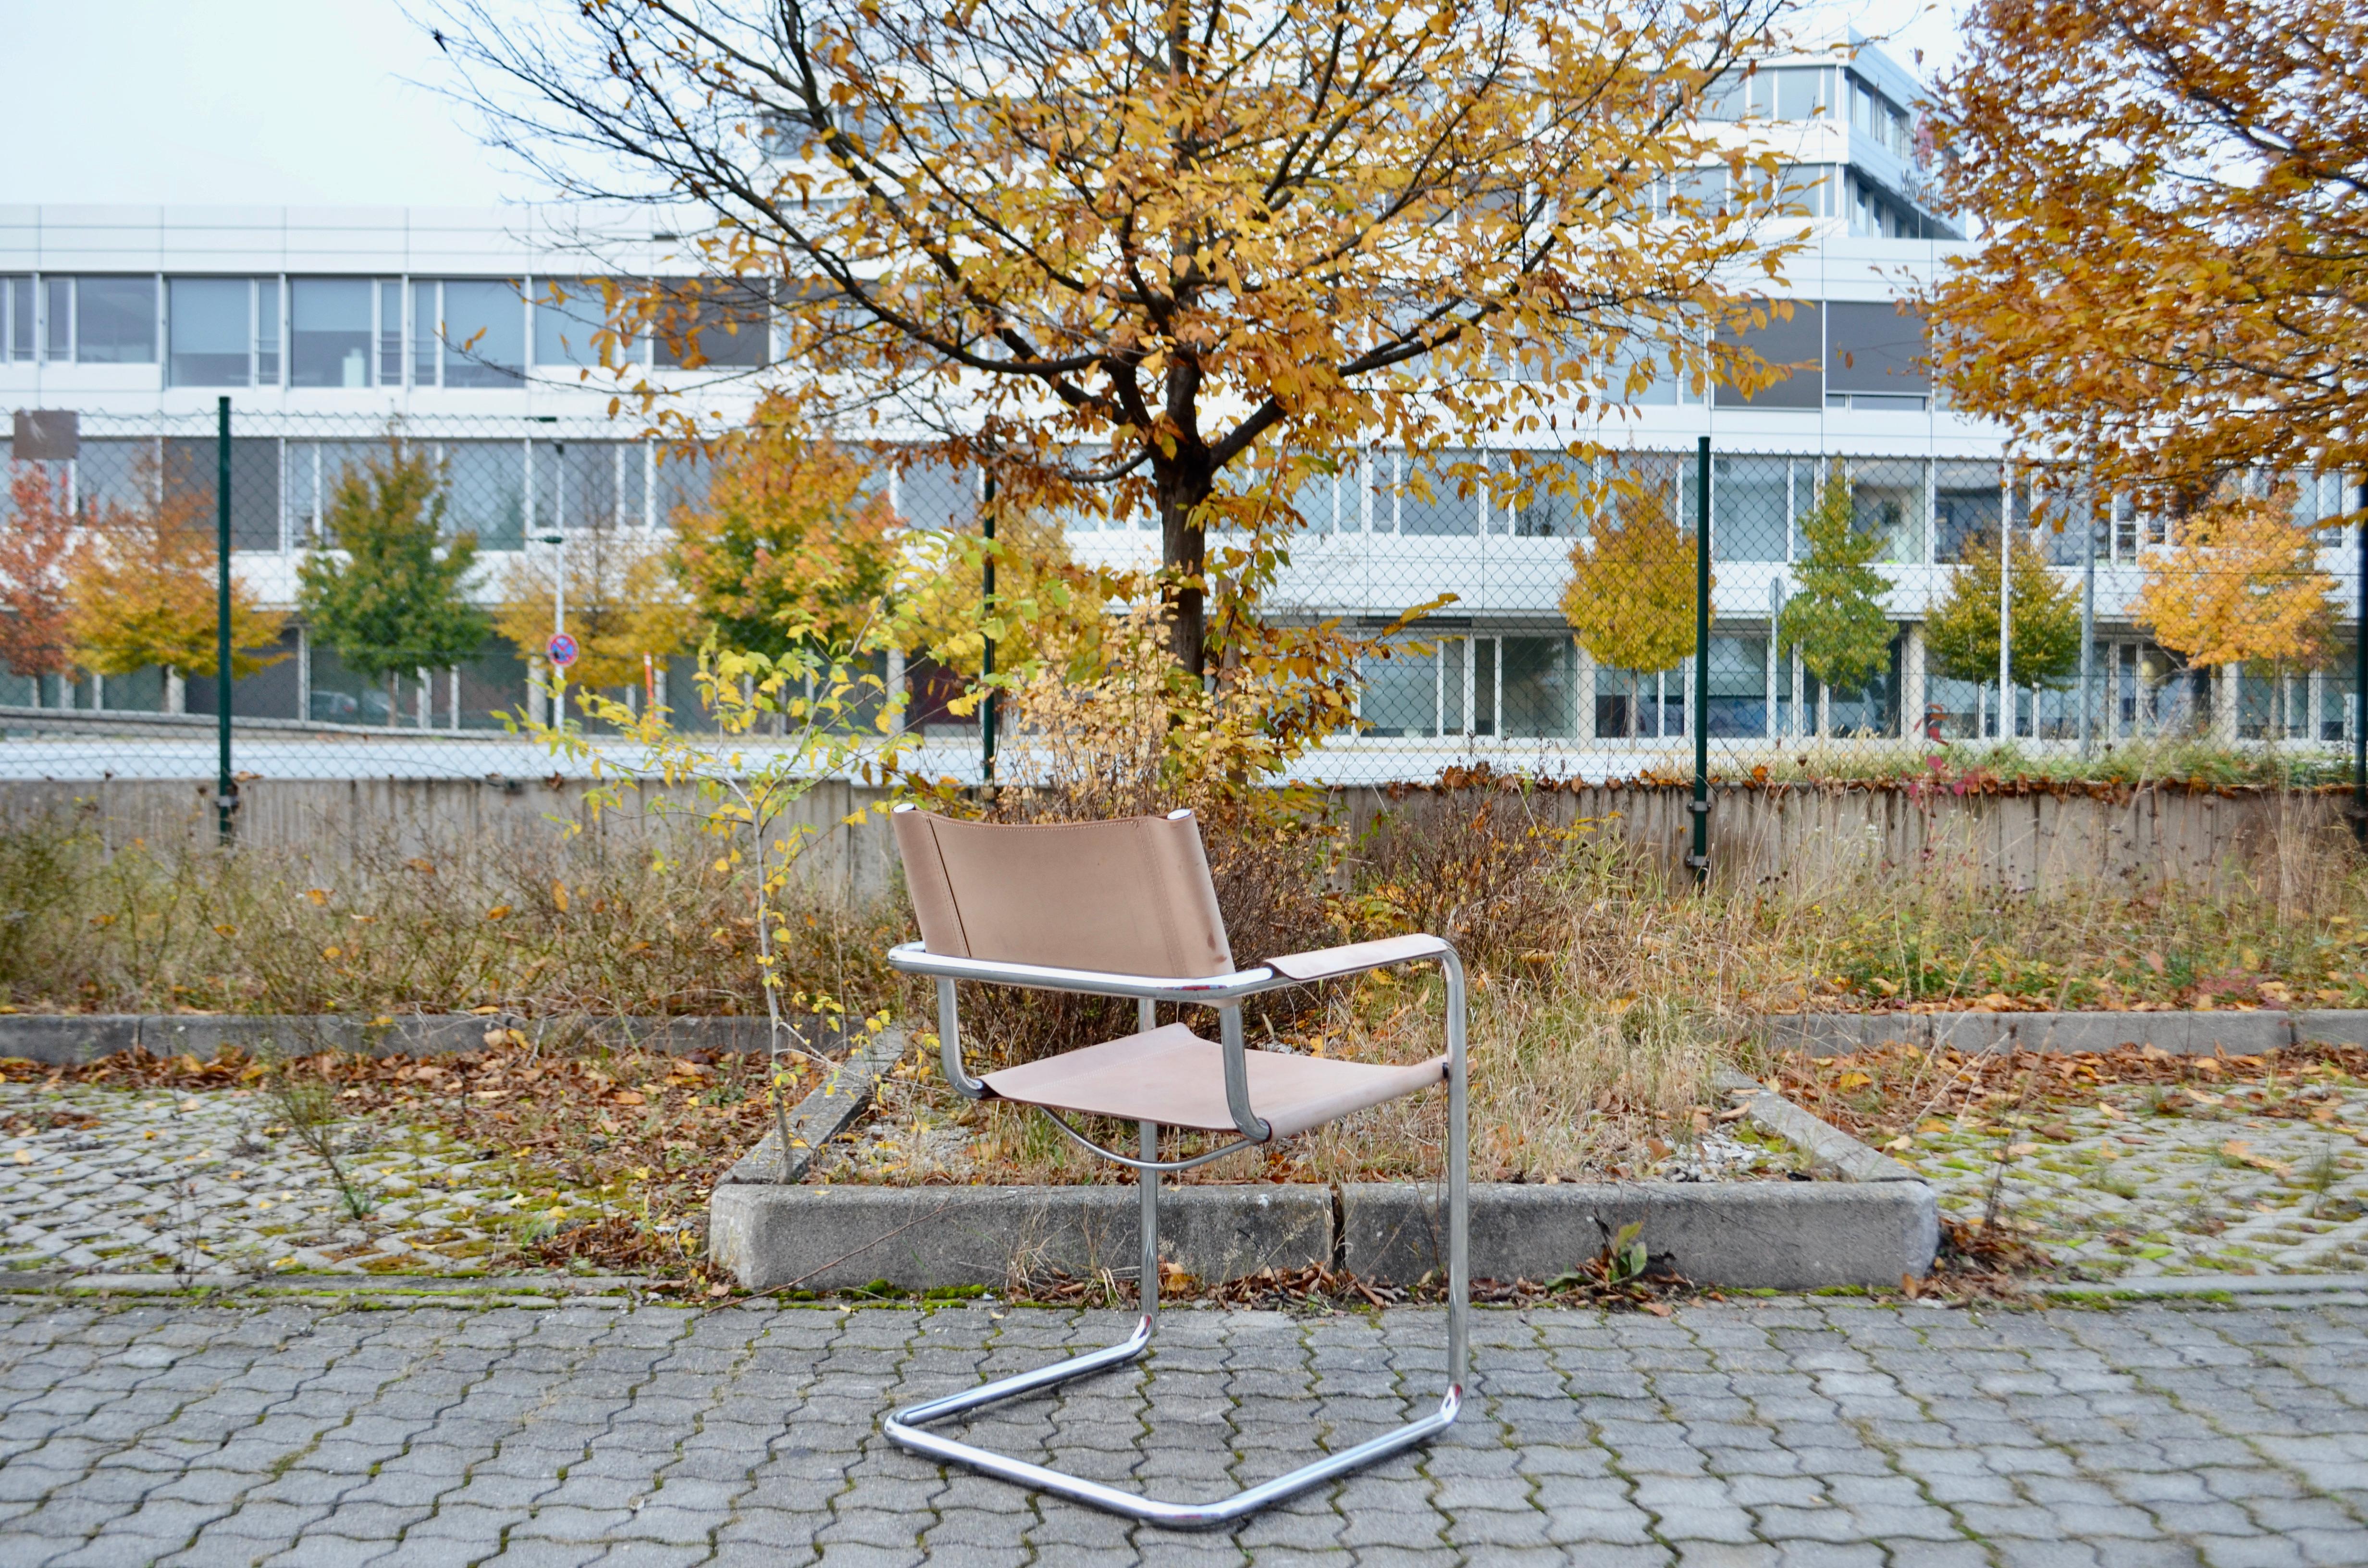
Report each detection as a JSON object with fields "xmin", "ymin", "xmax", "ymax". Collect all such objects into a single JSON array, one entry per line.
[{"xmin": 893, "ymin": 810, "xmax": 1233, "ymax": 980}]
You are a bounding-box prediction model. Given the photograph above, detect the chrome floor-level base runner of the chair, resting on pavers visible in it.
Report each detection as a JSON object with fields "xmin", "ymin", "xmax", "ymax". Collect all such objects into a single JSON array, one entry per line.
[{"xmin": 888, "ymin": 1312, "xmax": 1464, "ymax": 1530}]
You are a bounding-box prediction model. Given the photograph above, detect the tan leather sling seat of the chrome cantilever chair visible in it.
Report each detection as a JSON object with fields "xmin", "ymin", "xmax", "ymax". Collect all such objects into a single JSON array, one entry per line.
[{"xmin": 985, "ymin": 1023, "xmax": 1447, "ymax": 1137}]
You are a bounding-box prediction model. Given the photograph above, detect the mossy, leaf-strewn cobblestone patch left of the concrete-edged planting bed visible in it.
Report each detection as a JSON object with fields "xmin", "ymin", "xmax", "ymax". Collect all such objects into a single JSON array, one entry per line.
[{"xmin": 0, "ymin": 1082, "xmax": 611, "ymax": 1274}]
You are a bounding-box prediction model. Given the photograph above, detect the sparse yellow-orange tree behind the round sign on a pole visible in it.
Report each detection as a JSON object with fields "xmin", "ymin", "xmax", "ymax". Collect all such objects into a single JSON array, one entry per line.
[{"xmin": 493, "ymin": 524, "xmax": 691, "ymax": 689}]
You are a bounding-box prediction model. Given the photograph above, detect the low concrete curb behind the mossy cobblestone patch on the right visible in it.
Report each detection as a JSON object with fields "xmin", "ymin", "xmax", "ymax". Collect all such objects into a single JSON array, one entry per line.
[{"xmin": 1764, "ymin": 1009, "xmax": 2368, "ymax": 1056}]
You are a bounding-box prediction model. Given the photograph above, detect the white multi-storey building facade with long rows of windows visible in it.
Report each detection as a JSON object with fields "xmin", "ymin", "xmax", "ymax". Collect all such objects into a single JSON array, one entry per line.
[{"xmin": 0, "ymin": 34, "xmax": 2358, "ymax": 777}]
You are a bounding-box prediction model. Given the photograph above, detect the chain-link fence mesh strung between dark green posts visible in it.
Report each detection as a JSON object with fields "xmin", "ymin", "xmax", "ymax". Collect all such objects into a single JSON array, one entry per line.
[{"xmin": 0, "ymin": 410, "xmax": 2361, "ymax": 833}]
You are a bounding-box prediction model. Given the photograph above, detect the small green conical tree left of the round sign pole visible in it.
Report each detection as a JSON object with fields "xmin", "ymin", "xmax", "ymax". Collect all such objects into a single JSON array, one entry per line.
[{"xmin": 296, "ymin": 441, "xmax": 490, "ymax": 725}]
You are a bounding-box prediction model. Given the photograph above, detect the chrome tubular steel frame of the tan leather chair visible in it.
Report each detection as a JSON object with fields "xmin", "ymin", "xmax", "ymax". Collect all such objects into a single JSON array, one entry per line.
[{"xmin": 886, "ymin": 943, "xmax": 1470, "ymax": 1530}]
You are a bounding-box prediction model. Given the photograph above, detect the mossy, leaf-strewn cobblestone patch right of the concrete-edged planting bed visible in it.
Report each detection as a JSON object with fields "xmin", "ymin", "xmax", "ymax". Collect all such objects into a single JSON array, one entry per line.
[{"xmin": 1894, "ymin": 1071, "xmax": 2368, "ymax": 1279}]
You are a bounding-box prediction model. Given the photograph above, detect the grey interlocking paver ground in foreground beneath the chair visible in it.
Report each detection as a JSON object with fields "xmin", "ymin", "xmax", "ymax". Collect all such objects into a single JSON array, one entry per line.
[{"xmin": 0, "ymin": 1298, "xmax": 2368, "ymax": 1568}]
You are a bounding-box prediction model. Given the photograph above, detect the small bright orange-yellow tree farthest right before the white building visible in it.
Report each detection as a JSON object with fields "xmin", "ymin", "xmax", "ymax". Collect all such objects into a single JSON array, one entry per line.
[{"xmin": 2131, "ymin": 486, "xmax": 2335, "ymax": 673}]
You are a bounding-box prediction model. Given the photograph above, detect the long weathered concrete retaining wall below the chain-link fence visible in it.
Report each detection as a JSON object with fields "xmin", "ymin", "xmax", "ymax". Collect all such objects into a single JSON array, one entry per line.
[{"xmin": 0, "ymin": 779, "xmax": 2352, "ymax": 898}]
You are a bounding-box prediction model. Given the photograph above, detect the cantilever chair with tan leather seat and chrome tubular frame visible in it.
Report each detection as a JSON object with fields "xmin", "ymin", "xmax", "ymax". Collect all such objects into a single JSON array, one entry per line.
[{"xmin": 888, "ymin": 805, "xmax": 1470, "ymax": 1530}]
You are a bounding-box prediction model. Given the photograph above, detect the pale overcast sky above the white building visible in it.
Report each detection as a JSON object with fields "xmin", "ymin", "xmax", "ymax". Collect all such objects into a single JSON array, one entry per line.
[{"xmin": 0, "ymin": 0, "xmax": 1958, "ymax": 206}]
